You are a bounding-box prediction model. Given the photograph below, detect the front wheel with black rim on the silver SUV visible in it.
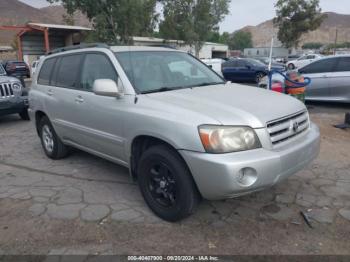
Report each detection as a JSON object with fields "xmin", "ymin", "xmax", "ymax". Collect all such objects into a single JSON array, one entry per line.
[{"xmin": 138, "ymin": 145, "xmax": 200, "ymax": 222}]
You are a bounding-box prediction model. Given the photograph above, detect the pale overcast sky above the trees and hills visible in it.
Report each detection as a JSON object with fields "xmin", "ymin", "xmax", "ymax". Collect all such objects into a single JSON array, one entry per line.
[{"xmin": 21, "ymin": 0, "xmax": 350, "ymax": 32}]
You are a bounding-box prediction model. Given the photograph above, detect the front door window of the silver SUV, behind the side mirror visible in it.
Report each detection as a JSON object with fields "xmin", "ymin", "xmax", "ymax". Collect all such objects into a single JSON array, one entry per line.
[{"xmin": 80, "ymin": 54, "xmax": 118, "ymax": 91}]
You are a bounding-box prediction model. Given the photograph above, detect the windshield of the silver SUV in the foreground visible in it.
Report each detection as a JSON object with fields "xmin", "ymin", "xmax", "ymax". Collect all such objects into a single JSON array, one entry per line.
[{"xmin": 115, "ymin": 51, "xmax": 224, "ymax": 93}]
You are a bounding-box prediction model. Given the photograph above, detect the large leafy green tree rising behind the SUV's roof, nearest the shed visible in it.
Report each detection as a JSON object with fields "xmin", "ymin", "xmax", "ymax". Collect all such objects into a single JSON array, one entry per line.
[{"xmin": 47, "ymin": 0, "xmax": 158, "ymax": 44}]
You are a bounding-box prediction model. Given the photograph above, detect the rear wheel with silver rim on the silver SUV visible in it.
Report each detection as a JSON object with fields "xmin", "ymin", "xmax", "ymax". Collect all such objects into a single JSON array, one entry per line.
[{"xmin": 39, "ymin": 116, "xmax": 69, "ymax": 160}]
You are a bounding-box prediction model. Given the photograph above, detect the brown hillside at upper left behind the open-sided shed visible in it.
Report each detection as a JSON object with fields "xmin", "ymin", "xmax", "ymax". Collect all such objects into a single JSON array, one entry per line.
[{"xmin": 0, "ymin": 0, "xmax": 91, "ymax": 45}]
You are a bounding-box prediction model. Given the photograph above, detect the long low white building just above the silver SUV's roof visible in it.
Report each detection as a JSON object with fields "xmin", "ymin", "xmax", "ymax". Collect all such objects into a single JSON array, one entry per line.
[{"xmin": 133, "ymin": 36, "xmax": 228, "ymax": 59}]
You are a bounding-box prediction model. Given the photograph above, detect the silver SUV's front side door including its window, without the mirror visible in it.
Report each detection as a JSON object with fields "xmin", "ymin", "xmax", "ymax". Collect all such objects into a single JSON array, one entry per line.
[{"xmin": 70, "ymin": 52, "xmax": 126, "ymax": 162}]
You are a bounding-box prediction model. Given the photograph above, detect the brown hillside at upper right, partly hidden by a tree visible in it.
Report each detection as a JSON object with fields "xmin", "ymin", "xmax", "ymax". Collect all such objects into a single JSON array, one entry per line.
[{"xmin": 241, "ymin": 12, "xmax": 350, "ymax": 47}]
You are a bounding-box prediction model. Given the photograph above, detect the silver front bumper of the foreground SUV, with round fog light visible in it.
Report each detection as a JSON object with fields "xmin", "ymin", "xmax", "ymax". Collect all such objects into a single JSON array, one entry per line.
[{"xmin": 180, "ymin": 124, "xmax": 320, "ymax": 200}]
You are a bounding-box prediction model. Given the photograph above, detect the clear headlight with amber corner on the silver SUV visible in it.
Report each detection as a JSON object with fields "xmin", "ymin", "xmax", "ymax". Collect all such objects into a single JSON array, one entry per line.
[{"xmin": 199, "ymin": 125, "xmax": 261, "ymax": 154}]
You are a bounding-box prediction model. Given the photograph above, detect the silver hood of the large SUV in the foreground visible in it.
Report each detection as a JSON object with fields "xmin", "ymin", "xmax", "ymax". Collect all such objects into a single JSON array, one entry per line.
[{"xmin": 146, "ymin": 84, "xmax": 306, "ymax": 128}]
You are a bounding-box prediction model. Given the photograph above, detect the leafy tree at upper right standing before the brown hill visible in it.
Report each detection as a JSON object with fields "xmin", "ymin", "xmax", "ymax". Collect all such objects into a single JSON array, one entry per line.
[{"xmin": 274, "ymin": 0, "xmax": 326, "ymax": 48}]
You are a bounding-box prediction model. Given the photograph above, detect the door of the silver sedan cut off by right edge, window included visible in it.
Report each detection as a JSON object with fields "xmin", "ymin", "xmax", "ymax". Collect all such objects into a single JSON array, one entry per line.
[{"xmin": 329, "ymin": 57, "xmax": 350, "ymax": 101}]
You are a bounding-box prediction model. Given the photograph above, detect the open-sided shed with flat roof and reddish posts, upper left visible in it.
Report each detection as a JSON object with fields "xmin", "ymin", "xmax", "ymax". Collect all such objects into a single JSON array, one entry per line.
[{"xmin": 0, "ymin": 23, "xmax": 91, "ymax": 65}]
